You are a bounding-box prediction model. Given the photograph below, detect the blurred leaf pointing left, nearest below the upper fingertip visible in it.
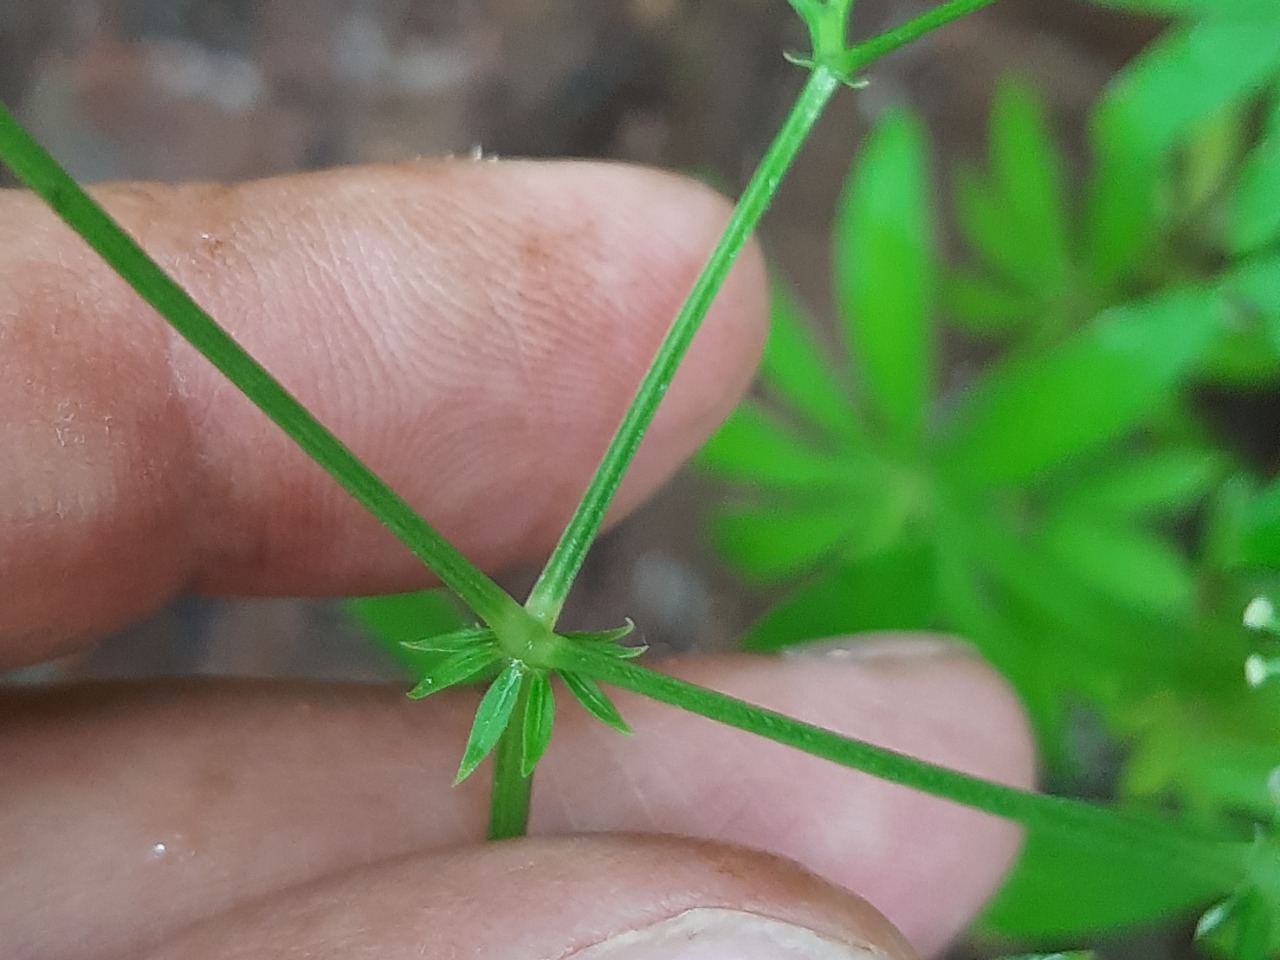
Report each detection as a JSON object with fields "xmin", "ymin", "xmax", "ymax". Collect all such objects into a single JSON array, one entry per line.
[{"xmin": 698, "ymin": 402, "xmax": 849, "ymax": 490}]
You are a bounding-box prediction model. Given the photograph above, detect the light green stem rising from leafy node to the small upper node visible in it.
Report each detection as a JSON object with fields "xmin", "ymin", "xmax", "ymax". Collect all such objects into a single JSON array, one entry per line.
[{"xmin": 525, "ymin": 67, "xmax": 840, "ymax": 626}]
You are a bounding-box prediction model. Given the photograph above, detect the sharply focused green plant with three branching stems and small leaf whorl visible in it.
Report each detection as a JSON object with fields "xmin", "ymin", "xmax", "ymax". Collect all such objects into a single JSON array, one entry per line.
[{"xmin": 0, "ymin": 0, "xmax": 1280, "ymax": 957}]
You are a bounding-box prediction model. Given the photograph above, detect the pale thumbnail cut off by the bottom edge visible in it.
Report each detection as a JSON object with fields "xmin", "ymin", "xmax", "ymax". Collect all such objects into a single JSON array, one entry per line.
[{"xmin": 570, "ymin": 908, "xmax": 881, "ymax": 960}]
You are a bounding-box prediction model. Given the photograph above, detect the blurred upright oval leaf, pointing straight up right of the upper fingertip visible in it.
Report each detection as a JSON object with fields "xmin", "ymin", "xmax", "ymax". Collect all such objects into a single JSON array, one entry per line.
[{"xmin": 833, "ymin": 111, "xmax": 937, "ymax": 452}]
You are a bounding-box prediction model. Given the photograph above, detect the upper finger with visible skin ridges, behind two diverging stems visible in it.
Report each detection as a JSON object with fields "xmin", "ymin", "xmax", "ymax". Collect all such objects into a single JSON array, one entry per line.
[{"xmin": 0, "ymin": 161, "xmax": 765, "ymax": 667}]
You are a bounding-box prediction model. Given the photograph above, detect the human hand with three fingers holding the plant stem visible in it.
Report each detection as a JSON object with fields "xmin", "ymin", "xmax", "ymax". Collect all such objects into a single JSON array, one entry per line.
[{"xmin": 0, "ymin": 163, "xmax": 1032, "ymax": 960}]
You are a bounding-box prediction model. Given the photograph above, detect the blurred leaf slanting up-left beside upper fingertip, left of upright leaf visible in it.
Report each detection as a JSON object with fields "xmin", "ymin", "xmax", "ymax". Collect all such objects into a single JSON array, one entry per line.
[{"xmin": 760, "ymin": 282, "xmax": 863, "ymax": 438}]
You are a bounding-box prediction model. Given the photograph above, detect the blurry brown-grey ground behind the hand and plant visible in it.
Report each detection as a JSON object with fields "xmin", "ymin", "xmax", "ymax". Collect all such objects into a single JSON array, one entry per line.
[{"xmin": 0, "ymin": 0, "xmax": 1156, "ymax": 681}]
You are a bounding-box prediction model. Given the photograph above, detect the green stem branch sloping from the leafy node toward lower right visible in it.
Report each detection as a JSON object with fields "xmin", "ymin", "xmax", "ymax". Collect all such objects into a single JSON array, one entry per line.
[{"xmin": 557, "ymin": 646, "xmax": 1242, "ymax": 890}]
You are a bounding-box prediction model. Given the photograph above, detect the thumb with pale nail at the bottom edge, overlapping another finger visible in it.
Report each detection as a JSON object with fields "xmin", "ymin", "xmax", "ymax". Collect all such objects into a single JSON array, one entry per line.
[{"xmin": 145, "ymin": 836, "xmax": 914, "ymax": 960}]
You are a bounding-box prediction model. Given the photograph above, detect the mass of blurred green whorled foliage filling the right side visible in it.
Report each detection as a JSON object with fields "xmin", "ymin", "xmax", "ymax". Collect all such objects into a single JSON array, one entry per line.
[{"xmin": 700, "ymin": 0, "xmax": 1280, "ymax": 960}]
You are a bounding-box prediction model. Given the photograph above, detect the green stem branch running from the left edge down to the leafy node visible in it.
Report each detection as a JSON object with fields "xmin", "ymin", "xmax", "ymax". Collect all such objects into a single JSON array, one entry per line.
[{"xmin": 0, "ymin": 104, "xmax": 529, "ymax": 640}]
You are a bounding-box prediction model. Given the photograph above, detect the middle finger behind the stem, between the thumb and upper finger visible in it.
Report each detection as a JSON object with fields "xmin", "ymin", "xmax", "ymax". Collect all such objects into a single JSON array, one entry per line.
[{"xmin": 0, "ymin": 648, "xmax": 1032, "ymax": 960}]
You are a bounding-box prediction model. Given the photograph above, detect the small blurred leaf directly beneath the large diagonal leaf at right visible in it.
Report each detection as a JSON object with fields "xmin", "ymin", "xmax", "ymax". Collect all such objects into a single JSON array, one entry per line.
[{"xmin": 1057, "ymin": 447, "xmax": 1228, "ymax": 517}]
